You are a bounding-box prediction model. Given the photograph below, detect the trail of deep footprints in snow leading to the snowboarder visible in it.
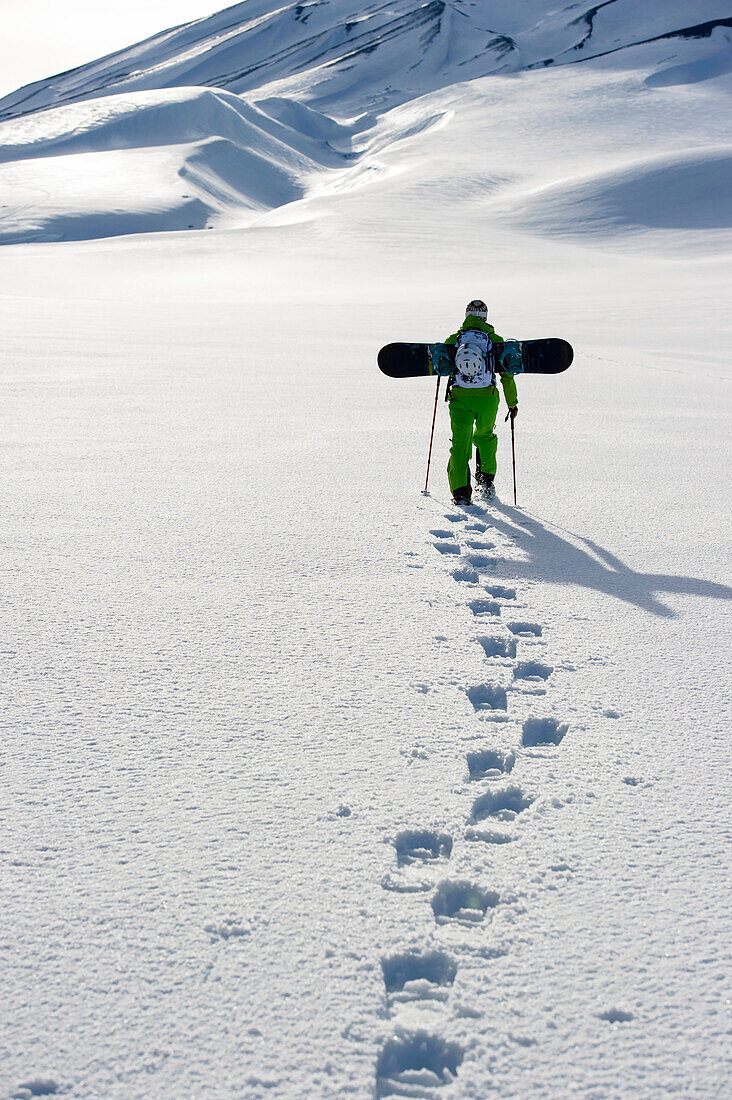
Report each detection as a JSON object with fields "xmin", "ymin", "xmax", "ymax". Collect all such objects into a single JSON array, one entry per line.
[{"xmin": 375, "ymin": 505, "xmax": 581, "ymax": 1100}]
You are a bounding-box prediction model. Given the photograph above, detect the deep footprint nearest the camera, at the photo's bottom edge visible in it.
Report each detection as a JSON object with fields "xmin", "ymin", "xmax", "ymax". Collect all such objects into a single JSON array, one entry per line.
[{"xmin": 375, "ymin": 1030, "xmax": 465, "ymax": 1100}]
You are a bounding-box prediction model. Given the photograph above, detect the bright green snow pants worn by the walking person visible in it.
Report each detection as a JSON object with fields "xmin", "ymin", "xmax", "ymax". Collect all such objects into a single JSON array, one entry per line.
[{"xmin": 447, "ymin": 386, "xmax": 499, "ymax": 493}]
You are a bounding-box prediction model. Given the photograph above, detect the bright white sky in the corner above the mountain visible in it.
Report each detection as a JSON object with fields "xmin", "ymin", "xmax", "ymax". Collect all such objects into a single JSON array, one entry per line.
[{"xmin": 0, "ymin": 0, "xmax": 228, "ymax": 96}]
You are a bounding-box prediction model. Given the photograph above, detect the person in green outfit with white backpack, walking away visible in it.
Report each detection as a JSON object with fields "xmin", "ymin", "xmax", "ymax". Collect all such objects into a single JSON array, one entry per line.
[{"xmin": 445, "ymin": 299, "xmax": 518, "ymax": 505}]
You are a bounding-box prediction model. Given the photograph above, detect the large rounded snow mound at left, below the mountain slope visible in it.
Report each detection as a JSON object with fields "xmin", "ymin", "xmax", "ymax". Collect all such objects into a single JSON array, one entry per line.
[{"xmin": 0, "ymin": 88, "xmax": 339, "ymax": 243}]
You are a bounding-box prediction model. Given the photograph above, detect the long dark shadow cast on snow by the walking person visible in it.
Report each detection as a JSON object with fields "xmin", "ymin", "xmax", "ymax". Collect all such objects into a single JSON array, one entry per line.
[{"xmin": 479, "ymin": 502, "xmax": 732, "ymax": 618}]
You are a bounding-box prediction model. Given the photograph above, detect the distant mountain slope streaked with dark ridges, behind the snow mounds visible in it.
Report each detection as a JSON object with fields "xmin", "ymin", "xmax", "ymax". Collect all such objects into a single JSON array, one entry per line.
[{"xmin": 0, "ymin": 0, "xmax": 732, "ymax": 119}]
